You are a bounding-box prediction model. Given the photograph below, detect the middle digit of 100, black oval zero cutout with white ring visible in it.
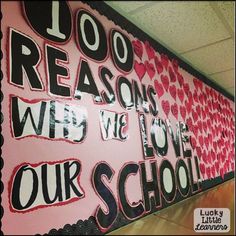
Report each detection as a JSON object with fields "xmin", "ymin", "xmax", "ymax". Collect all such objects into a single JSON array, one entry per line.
[{"xmin": 76, "ymin": 10, "xmax": 108, "ymax": 62}]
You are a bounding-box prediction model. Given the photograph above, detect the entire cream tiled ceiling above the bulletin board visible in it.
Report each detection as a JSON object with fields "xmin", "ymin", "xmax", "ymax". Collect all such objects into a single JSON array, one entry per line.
[{"xmin": 105, "ymin": 1, "xmax": 235, "ymax": 96}]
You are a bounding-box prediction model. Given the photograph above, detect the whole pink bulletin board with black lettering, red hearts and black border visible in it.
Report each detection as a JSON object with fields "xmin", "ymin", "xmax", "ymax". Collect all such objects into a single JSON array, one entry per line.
[{"xmin": 1, "ymin": 1, "xmax": 235, "ymax": 235}]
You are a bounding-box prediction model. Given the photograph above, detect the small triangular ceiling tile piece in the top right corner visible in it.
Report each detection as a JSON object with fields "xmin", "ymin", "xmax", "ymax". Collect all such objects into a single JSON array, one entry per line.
[{"xmin": 215, "ymin": 1, "xmax": 235, "ymax": 30}]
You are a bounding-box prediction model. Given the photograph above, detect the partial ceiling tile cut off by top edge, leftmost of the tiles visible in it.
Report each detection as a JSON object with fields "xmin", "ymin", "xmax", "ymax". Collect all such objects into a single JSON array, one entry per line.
[{"xmin": 105, "ymin": 1, "xmax": 148, "ymax": 13}]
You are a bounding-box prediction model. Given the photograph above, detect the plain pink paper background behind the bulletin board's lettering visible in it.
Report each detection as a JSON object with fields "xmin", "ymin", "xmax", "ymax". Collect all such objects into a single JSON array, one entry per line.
[{"xmin": 1, "ymin": 1, "xmax": 234, "ymax": 234}]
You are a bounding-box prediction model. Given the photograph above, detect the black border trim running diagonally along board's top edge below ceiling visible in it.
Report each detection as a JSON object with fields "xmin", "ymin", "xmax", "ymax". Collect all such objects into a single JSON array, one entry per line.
[{"xmin": 82, "ymin": 1, "xmax": 235, "ymax": 102}]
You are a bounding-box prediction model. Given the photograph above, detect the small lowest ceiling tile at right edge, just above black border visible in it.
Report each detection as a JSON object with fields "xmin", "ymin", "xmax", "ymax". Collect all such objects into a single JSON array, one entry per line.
[{"xmin": 210, "ymin": 70, "xmax": 234, "ymax": 89}]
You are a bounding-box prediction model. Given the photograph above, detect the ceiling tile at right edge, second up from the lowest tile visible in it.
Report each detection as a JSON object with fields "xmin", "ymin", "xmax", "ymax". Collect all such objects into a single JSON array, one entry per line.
[{"xmin": 181, "ymin": 39, "xmax": 234, "ymax": 74}]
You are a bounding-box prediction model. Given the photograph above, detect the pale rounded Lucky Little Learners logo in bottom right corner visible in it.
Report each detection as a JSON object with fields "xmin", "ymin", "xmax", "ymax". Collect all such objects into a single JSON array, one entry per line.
[{"xmin": 193, "ymin": 208, "xmax": 230, "ymax": 233}]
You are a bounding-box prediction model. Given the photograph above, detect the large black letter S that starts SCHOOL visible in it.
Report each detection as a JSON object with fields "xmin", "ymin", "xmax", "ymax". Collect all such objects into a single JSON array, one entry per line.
[{"xmin": 92, "ymin": 162, "xmax": 118, "ymax": 232}]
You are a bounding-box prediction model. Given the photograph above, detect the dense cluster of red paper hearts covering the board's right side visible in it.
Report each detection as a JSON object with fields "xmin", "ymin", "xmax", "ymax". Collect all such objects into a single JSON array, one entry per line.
[{"xmin": 132, "ymin": 37, "xmax": 235, "ymax": 182}]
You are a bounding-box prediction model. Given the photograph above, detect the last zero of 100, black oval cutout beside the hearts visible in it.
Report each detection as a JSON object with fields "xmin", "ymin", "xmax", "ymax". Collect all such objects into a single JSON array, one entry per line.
[{"xmin": 110, "ymin": 29, "xmax": 134, "ymax": 73}]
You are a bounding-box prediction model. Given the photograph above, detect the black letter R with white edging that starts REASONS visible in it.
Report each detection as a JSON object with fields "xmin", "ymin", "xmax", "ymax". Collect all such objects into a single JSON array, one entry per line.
[{"xmin": 9, "ymin": 28, "xmax": 43, "ymax": 90}]
